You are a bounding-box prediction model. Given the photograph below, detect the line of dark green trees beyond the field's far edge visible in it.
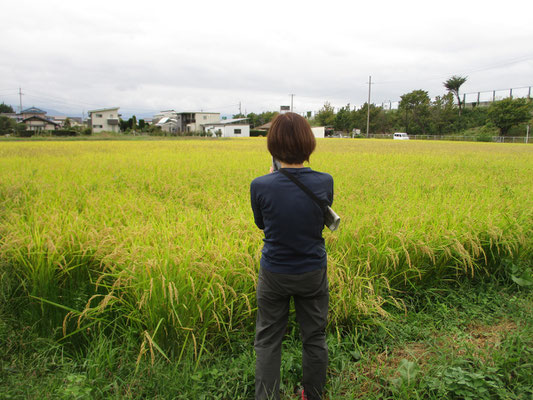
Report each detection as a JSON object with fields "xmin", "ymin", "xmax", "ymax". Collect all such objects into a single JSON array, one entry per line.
[{"xmin": 234, "ymin": 75, "xmax": 533, "ymax": 135}]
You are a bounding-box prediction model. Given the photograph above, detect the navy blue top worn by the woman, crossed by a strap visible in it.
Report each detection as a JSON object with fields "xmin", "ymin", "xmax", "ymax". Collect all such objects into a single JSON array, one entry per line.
[{"xmin": 250, "ymin": 168, "xmax": 333, "ymax": 274}]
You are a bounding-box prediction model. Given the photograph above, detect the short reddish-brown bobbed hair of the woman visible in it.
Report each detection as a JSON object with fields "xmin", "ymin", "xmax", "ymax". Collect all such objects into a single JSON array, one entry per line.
[{"xmin": 267, "ymin": 113, "xmax": 316, "ymax": 164}]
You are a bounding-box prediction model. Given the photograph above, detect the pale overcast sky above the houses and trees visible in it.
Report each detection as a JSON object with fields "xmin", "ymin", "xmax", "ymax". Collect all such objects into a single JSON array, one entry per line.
[{"xmin": 0, "ymin": 0, "xmax": 533, "ymax": 115}]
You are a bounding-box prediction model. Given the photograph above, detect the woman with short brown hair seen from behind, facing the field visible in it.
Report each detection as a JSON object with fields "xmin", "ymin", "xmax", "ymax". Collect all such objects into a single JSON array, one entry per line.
[{"xmin": 250, "ymin": 113, "xmax": 333, "ymax": 400}]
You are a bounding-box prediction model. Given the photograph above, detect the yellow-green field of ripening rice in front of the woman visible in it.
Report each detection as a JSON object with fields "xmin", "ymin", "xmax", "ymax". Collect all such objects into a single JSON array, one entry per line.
[{"xmin": 0, "ymin": 138, "xmax": 533, "ymax": 358}]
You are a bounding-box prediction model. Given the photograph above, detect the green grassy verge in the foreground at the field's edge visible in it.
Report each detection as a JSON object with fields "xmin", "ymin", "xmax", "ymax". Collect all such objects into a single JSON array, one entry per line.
[{"xmin": 0, "ymin": 281, "xmax": 533, "ymax": 400}]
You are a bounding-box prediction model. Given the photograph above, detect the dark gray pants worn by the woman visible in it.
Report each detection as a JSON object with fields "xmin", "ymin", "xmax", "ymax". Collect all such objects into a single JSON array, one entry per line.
[{"xmin": 255, "ymin": 268, "xmax": 329, "ymax": 400}]
